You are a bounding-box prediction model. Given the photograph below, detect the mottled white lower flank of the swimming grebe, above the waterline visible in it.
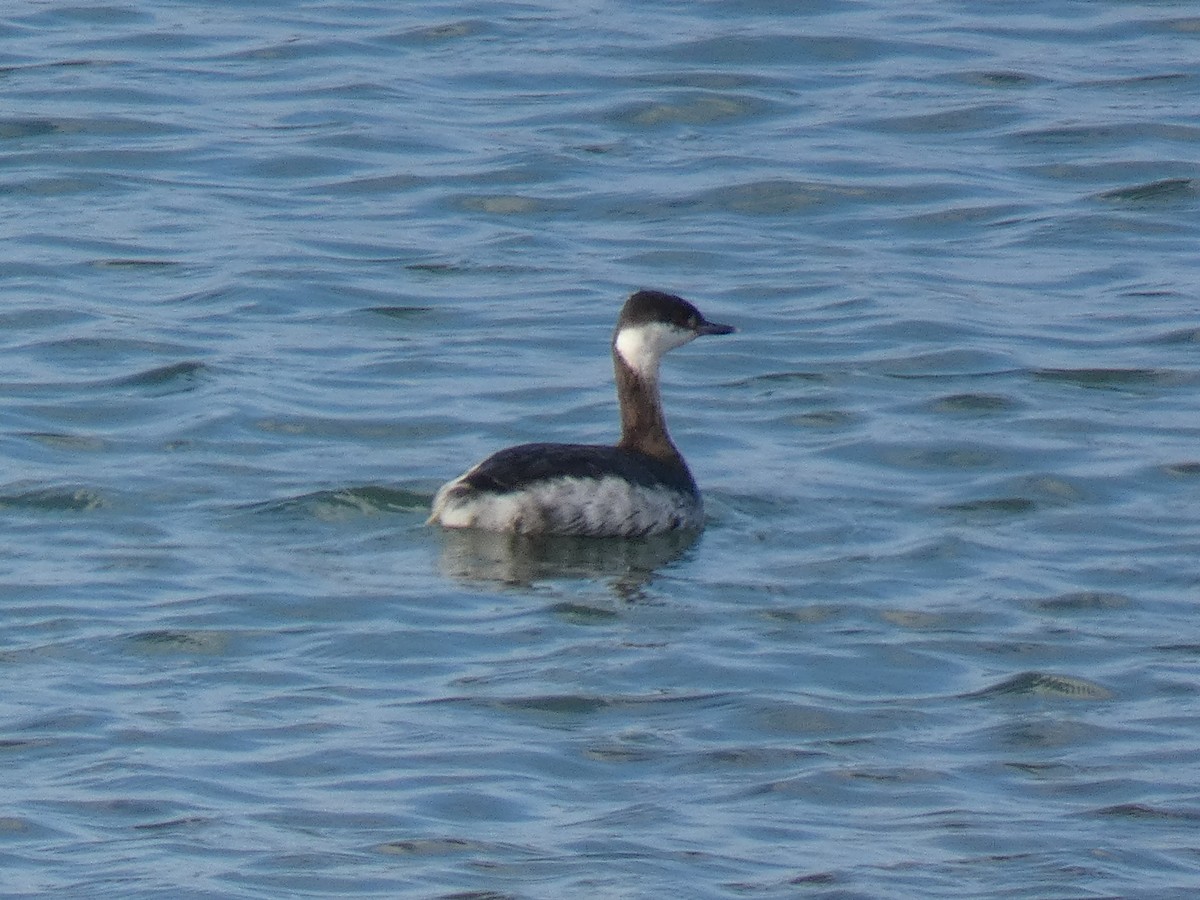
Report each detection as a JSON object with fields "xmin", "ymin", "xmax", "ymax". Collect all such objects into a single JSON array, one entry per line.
[{"xmin": 430, "ymin": 476, "xmax": 704, "ymax": 538}]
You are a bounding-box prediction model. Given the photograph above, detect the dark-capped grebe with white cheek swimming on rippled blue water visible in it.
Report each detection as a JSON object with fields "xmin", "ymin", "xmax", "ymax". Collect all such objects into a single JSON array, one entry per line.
[{"xmin": 428, "ymin": 290, "xmax": 734, "ymax": 538}]
